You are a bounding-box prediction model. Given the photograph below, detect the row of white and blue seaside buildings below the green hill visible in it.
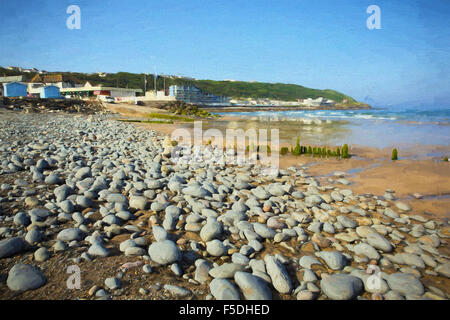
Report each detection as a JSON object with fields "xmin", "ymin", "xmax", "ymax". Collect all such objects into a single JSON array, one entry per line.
[{"xmin": 0, "ymin": 67, "xmax": 335, "ymax": 107}]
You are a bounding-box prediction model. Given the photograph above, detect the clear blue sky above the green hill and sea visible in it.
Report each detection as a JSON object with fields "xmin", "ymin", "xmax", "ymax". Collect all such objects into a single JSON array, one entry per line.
[{"xmin": 0, "ymin": 0, "xmax": 450, "ymax": 105}]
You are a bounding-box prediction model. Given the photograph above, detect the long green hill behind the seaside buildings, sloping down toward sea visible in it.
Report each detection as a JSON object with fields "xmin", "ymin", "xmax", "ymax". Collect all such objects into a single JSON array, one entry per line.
[{"xmin": 0, "ymin": 67, "xmax": 362, "ymax": 105}]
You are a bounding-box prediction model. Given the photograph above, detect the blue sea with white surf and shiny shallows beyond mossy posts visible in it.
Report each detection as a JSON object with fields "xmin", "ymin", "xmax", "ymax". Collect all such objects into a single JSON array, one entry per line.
[{"xmin": 215, "ymin": 106, "xmax": 450, "ymax": 148}]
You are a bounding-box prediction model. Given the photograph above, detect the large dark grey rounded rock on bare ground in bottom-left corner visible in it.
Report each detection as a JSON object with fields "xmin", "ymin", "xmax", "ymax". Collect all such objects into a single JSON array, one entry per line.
[{"xmin": 6, "ymin": 263, "xmax": 47, "ymax": 291}]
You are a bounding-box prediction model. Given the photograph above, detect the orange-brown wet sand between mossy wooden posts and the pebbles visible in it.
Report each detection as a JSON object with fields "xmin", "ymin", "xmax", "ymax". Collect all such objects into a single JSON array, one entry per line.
[{"xmin": 280, "ymin": 154, "xmax": 450, "ymax": 222}]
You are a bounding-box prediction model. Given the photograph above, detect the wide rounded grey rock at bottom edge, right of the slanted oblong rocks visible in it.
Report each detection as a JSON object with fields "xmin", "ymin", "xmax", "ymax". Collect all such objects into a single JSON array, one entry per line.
[{"xmin": 320, "ymin": 274, "xmax": 364, "ymax": 300}]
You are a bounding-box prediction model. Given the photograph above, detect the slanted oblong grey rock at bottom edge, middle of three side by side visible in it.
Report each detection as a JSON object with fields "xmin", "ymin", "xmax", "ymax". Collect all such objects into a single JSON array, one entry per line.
[{"xmin": 234, "ymin": 271, "xmax": 272, "ymax": 300}]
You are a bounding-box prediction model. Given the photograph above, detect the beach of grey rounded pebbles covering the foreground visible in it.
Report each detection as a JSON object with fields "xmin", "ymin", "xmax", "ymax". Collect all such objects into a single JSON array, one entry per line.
[{"xmin": 0, "ymin": 110, "xmax": 450, "ymax": 300}]
